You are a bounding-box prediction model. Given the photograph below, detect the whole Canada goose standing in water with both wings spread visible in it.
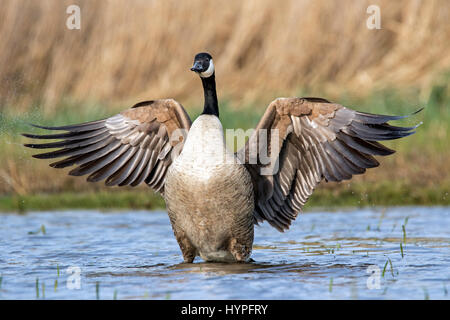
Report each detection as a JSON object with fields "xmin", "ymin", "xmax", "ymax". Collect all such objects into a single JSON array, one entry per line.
[{"xmin": 24, "ymin": 53, "xmax": 420, "ymax": 262}]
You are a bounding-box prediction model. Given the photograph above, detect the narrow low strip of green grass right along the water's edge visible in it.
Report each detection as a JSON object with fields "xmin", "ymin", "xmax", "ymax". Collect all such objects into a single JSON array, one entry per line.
[{"xmin": 0, "ymin": 181, "xmax": 450, "ymax": 212}]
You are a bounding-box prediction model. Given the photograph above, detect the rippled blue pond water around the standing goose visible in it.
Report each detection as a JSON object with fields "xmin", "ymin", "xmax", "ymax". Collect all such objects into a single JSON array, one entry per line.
[{"xmin": 0, "ymin": 207, "xmax": 450, "ymax": 299}]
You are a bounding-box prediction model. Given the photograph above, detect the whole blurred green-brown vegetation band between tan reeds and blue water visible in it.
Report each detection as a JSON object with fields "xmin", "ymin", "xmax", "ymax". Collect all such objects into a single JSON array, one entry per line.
[{"xmin": 0, "ymin": 86, "xmax": 450, "ymax": 212}]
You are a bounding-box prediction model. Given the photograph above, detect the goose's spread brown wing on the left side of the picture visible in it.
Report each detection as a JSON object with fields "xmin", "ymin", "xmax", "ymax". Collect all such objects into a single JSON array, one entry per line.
[{"xmin": 23, "ymin": 99, "xmax": 191, "ymax": 193}]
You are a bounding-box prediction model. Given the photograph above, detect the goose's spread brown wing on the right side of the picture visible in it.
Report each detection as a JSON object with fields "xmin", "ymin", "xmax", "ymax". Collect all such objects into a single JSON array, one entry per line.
[{"xmin": 238, "ymin": 98, "xmax": 420, "ymax": 231}]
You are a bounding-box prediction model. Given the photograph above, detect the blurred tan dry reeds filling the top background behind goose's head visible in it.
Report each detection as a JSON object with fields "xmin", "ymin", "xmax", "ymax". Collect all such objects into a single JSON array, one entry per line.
[{"xmin": 0, "ymin": 0, "xmax": 450, "ymax": 111}]
